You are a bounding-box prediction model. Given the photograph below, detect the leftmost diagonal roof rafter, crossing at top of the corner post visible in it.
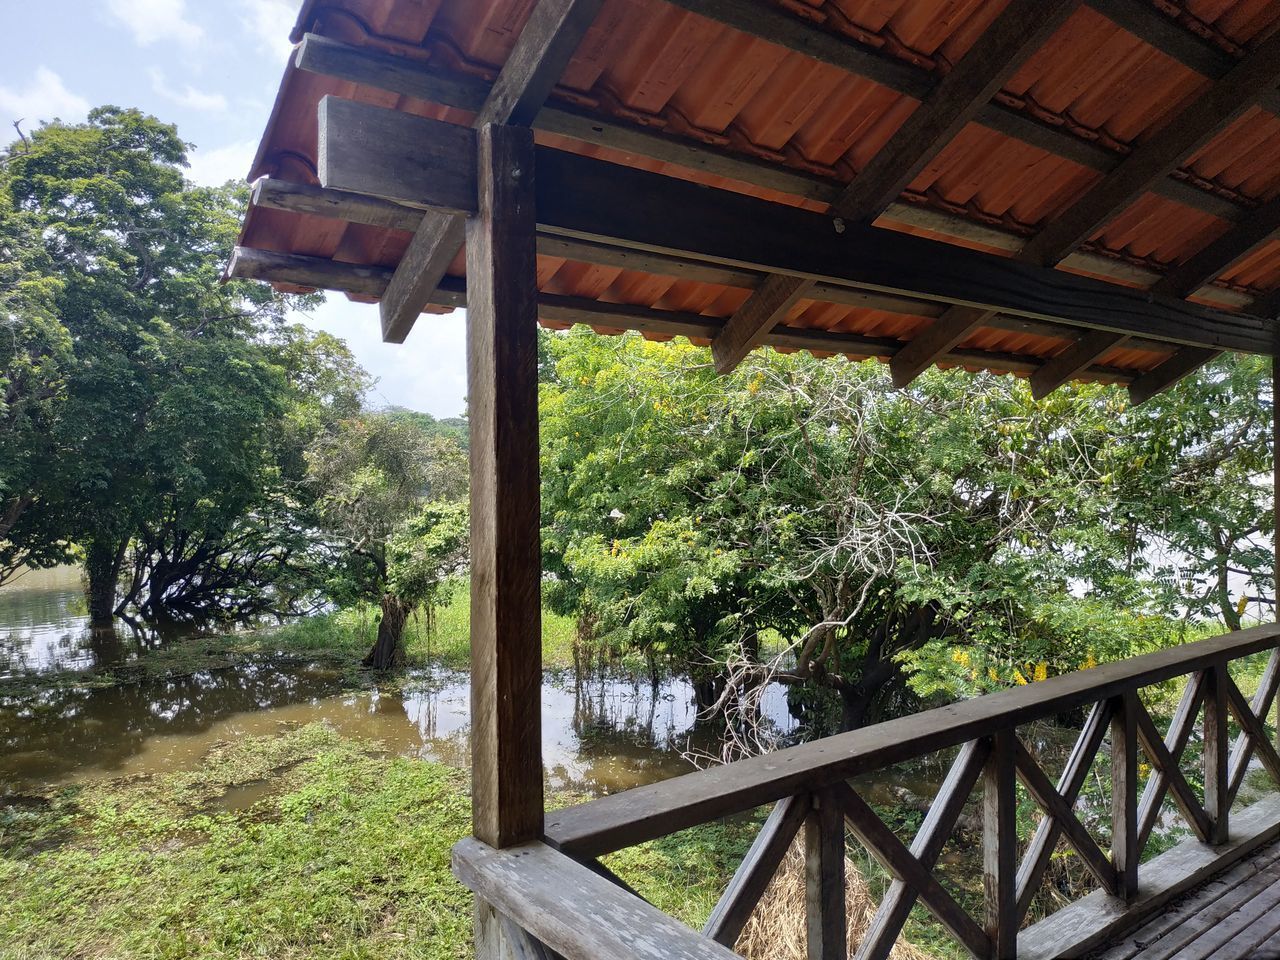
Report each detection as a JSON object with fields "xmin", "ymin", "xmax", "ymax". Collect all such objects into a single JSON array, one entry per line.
[{"xmin": 380, "ymin": 0, "xmax": 603, "ymax": 343}]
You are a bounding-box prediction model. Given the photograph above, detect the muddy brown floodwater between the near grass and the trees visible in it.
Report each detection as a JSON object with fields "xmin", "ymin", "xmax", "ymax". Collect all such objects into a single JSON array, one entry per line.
[{"xmin": 0, "ymin": 662, "xmax": 794, "ymax": 795}]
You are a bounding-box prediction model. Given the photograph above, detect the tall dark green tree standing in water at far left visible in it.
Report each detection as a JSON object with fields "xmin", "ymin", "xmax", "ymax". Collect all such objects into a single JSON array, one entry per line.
[{"xmin": 0, "ymin": 106, "xmax": 322, "ymax": 622}]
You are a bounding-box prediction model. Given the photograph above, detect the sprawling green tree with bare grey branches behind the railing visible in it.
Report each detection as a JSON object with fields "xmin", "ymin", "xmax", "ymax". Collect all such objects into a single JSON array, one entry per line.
[{"xmin": 541, "ymin": 333, "xmax": 1270, "ymax": 726}]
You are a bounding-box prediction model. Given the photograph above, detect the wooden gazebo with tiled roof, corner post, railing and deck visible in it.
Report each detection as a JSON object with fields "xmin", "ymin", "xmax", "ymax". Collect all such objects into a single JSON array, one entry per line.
[{"xmin": 230, "ymin": 0, "xmax": 1280, "ymax": 960}]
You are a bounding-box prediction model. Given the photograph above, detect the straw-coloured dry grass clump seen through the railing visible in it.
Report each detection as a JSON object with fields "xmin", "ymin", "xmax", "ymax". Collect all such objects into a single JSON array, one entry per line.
[{"xmin": 736, "ymin": 841, "xmax": 934, "ymax": 960}]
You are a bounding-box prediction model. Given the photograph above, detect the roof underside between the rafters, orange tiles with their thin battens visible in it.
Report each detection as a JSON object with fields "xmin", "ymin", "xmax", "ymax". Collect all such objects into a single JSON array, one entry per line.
[{"xmin": 230, "ymin": 0, "xmax": 1280, "ymax": 394}]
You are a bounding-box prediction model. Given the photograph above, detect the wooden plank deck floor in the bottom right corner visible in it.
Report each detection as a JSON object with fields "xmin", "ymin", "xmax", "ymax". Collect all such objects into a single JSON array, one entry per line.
[{"xmin": 1093, "ymin": 844, "xmax": 1280, "ymax": 960}]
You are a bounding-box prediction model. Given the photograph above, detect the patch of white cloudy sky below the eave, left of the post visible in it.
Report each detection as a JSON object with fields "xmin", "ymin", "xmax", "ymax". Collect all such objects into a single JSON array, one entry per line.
[{"xmin": 298, "ymin": 293, "xmax": 467, "ymax": 417}]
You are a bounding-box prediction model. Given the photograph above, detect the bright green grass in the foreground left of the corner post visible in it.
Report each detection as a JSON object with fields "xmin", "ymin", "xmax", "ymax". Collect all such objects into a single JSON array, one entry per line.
[{"xmin": 0, "ymin": 724, "xmax": 471, "ymax": 960}]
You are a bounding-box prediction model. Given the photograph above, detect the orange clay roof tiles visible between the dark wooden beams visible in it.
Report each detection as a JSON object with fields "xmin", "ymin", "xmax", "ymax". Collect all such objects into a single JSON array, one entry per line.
[{"xmin": 241, "ymin": 0, "xmax": 1280, "ymax": 379}]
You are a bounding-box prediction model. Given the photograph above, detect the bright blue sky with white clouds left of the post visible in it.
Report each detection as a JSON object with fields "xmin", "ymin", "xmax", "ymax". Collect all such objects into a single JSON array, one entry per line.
[{"xmin": 0, "ymin": 0, "xmax": 466, "ymax": 417}]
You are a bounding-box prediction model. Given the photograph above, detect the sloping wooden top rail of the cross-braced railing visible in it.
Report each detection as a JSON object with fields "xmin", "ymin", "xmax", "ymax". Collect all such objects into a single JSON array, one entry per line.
[{"xmin": 545, "ymin": 623, "xmax": 1280, "ymax": 856}]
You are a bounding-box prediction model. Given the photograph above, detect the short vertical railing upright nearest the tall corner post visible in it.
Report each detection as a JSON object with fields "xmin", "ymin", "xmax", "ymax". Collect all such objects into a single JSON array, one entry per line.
[{"xmin": 804, "ymin": 790, "xmax": 849, "ymax": 960}]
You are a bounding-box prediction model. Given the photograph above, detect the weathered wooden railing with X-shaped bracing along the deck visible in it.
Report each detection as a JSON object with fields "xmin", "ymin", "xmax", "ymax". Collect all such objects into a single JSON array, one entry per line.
[{"xmin": 454, "ymin": 625, "xmax": 1280, "ymax": 960}]
